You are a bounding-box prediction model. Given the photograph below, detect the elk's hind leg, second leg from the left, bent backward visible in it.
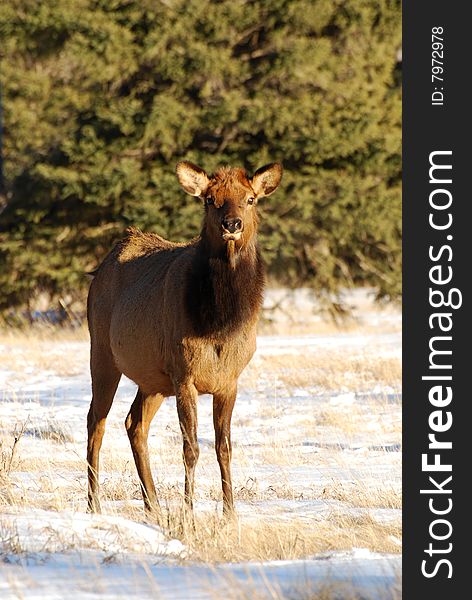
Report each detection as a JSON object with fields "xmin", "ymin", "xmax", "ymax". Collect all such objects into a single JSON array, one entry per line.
[{"xmin": 125, "ymin": 390, "xmax": 164, "ymax": 513}]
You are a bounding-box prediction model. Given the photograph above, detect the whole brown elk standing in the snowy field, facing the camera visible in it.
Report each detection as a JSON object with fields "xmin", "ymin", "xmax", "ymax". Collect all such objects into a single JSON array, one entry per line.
[{"xmin": 87, "ymin": 161, "xmax": 282, "ymax": 514}]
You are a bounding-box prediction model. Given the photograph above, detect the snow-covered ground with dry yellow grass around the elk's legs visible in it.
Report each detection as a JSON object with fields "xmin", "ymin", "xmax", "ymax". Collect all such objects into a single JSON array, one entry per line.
[{"xmin": 0, "ymin": 290, "xmax": 401, "ymax": 600}]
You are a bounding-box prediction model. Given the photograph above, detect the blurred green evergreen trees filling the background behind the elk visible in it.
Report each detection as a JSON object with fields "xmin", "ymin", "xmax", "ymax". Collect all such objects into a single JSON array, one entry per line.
[{"xmin": 0, "ymin": 0, "xmax": 401, "ymax": 308}]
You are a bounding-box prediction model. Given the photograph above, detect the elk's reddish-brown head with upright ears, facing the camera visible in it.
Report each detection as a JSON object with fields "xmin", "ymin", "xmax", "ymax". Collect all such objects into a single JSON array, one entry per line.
[{"xmin": 176, "ymin": 161, "xmax": 282, "ymax": 269}]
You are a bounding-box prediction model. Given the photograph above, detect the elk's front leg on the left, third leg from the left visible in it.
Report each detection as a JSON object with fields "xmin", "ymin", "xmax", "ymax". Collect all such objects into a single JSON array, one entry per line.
[{"xmin": 175, "ymin": 383, "xmax": 200, "ymax": 510}]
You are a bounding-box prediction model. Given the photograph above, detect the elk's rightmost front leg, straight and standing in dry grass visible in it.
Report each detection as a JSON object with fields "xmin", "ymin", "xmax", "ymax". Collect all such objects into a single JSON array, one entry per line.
[{"xmin": 213, "ymin": 386, "xmax": 236, "ymax": 515}]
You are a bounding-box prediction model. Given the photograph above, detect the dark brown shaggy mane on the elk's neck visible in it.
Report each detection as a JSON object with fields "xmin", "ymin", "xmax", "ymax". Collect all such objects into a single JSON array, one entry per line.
[{"xmin": 185, "ymin": 242, "xmax": 265, "ymax": 337}]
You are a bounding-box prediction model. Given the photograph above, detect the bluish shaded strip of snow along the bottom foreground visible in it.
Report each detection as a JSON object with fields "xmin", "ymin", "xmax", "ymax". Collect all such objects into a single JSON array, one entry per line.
[{"xmin": 0, "ymin": 549, "xmax": 401, "ymax": 600}]
